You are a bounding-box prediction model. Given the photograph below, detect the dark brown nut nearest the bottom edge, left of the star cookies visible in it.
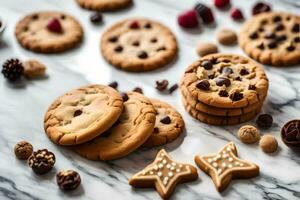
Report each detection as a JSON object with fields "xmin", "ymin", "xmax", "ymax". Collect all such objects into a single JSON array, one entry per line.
[{"xmin": 56, "ymin": 170, "xmax": 81, "ymax": 190}]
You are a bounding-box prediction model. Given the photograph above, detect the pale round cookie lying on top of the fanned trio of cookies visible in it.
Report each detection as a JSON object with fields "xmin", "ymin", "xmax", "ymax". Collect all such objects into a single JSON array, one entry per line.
[{"xmin": 44, "ymin": 85, "xmax": 123, "ymax": 145}]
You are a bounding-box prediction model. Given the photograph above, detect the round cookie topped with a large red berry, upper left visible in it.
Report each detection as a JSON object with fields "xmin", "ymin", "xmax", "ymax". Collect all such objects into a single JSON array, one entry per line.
[{"xmin": 15, "ymin": 12, "xmax": 83, "ymax": 53}]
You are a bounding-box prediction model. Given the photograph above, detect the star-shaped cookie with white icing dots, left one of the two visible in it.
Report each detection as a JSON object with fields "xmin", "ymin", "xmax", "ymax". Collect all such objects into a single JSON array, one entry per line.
[{"xmin": 129, "ymin": 149, "xmax": 198, "ymax": 199}]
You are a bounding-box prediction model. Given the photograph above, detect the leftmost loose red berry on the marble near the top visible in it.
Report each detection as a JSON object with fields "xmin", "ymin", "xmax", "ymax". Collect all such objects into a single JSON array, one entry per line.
[{"xmin": 177, "ymin": 10, "xmax": 199, "ymax": 28}]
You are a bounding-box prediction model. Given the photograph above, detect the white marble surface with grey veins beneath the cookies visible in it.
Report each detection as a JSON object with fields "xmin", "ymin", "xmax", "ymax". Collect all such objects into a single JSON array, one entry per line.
[{"xmin": 0, "ymin": 0, "xmax": 300, "ymax": 200}]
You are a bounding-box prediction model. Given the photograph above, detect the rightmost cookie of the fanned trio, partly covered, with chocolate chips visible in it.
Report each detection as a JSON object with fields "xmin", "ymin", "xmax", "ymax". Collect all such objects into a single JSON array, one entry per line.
[{"xmin": 143, "ymin": 99, "xmax": 184, "ymax": 147}]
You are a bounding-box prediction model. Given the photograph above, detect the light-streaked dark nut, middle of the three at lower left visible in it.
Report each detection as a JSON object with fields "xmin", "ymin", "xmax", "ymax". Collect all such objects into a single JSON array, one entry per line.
[{"xmin": 28, "ymin": 149, "xmax": 55, "ymax": 174}]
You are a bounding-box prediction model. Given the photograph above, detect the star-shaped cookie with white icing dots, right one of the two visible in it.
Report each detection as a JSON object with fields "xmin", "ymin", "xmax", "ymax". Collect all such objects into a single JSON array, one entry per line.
[{"xmin": 195, "ymin": 142, "xmax": 259, "ymax": 192}]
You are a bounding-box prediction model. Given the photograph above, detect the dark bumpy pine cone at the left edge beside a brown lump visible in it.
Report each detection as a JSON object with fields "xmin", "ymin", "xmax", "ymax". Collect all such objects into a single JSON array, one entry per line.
[{"xmin": 1, "ymin": 59, "xmax": 24, "ymax": 81}]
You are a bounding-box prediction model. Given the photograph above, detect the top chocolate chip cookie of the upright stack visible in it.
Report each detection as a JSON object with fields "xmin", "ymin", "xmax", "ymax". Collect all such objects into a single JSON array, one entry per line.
[{"xmin": 181, "ymin": 54, "xmax": 269, "ymax": 108}]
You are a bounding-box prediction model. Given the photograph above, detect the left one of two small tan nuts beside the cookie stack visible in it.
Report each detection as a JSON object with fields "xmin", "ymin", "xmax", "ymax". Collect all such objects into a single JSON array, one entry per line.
[{"xmin": 237, "ymin": 125, "xmax": 260, "ymax": 144}]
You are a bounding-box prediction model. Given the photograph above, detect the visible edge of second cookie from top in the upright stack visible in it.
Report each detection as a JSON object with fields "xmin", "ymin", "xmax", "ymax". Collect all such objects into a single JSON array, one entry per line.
[{"xmin": 180, "ymin": 85, "xmax": 263, "ymax": 117}]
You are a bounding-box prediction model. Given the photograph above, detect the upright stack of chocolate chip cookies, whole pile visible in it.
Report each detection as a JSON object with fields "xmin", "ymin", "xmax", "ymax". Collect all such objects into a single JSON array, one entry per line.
[{"xmin": 180, "ymin": 54, "xmax": 269, "ymax": 125}]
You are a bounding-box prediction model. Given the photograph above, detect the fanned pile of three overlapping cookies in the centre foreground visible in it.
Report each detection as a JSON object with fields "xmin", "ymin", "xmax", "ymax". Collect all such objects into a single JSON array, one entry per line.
[{"xmin": 44, "ymin": 85, "xmax": 184, "ymax": 160}]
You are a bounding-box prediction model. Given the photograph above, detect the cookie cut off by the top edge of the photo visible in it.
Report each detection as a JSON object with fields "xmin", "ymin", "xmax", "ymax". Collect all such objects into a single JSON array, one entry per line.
[{"xmin": 77, "ymin": 0, "xmax": 132, "ymax": 11}]
